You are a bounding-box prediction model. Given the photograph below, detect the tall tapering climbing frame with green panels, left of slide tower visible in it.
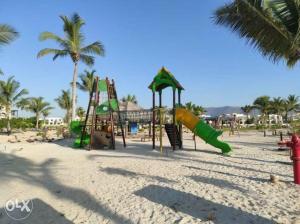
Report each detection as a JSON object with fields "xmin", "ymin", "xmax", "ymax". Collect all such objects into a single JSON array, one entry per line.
[{"xmin": 71, "ymin": 77, "xmax": 126, "ymax": 150}]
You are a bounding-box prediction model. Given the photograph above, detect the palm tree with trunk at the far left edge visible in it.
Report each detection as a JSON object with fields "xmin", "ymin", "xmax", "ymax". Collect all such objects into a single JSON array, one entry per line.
[{"xmin": 0, "ymin": 76, "xmax": 28, "ymax": 135}]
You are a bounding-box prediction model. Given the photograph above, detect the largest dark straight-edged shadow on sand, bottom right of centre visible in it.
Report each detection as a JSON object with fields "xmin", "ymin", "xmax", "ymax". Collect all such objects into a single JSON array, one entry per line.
[{"xmin": 134, "ymin": 185, "xmax": 275, "ymax": 224}]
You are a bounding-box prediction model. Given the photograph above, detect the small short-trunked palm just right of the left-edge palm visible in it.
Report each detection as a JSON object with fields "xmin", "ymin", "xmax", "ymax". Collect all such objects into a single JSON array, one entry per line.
[{"xmin": 22, "ymin": 97, "xmax": 53, "ymax": 129}]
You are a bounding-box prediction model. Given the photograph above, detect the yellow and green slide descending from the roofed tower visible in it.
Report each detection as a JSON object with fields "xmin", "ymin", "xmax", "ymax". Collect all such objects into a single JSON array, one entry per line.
[{"xmin": 176, "ymin": 108, "xmax": 231, "ymax": 154}]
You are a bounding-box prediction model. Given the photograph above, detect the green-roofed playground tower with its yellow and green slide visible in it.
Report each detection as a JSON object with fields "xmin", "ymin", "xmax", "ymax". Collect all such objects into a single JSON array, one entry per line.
[{"xmin": 148, "ymin": 67, "xmax": 231, "ymax": 154}]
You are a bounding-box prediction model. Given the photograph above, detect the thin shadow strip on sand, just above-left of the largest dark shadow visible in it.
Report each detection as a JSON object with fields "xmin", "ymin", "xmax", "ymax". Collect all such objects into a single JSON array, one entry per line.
[{"xmin": 101, "ymin": 167, "xmax": 175, "ymax": 183}]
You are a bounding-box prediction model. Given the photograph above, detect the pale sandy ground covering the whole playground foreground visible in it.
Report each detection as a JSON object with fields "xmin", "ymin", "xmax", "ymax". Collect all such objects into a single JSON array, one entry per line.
[{"xmin": 0, "ymin": 133, "xmax": 300, "ymax": 224}]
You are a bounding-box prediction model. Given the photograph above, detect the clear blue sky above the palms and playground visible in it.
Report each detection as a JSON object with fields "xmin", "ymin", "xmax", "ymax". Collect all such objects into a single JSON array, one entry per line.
[{"xmin": 0, "ymin": 0, "xmax": 300, "ymax": 115}]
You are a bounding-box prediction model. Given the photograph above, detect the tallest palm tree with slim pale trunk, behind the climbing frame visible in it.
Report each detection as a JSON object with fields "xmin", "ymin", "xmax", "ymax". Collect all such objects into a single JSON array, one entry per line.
[{"xmin": 37, "ymin": 13, "xmax": 104, "ymax": 120}]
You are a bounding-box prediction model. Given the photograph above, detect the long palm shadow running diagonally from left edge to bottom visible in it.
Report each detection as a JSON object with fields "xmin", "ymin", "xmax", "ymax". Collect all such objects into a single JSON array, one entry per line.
[{"xmin": 0, "ymin": 152, "xmax": 132, "ymax": 223}]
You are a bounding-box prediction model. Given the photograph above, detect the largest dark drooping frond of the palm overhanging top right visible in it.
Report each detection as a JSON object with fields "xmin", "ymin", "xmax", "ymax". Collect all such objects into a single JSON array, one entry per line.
[{"xmin": 214, "ymin": 0, "xmax": 297, "ymax": 62}]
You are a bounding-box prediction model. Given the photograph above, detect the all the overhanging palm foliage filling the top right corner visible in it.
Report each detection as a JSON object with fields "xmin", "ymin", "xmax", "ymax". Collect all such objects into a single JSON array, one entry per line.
[{"xmin": 214, "ymin": 0, "xmax": 300, "ymax": 67}]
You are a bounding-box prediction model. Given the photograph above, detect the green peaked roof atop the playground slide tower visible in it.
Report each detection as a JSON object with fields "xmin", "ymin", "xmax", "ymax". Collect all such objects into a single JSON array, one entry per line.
[{"xmin": 148, "ymin": 67, "xmax": 184, "ymax": 92}]
